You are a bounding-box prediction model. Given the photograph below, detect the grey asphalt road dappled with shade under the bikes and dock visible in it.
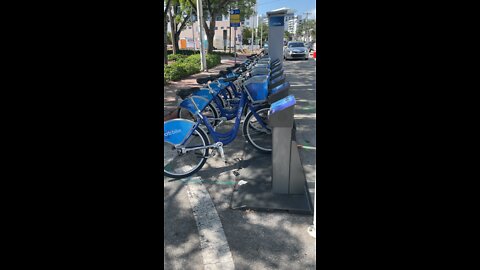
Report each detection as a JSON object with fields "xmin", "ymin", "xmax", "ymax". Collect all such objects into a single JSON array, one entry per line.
[{"xmin": 164, "ymin": 59, "xmax": 316, "ymax": 269}]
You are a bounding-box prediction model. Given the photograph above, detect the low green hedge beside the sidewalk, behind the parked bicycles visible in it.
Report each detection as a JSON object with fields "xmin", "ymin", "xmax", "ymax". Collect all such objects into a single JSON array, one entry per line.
[{"xmin": 164, "ymin": 53, "xmax": 221, "ymax": 84}]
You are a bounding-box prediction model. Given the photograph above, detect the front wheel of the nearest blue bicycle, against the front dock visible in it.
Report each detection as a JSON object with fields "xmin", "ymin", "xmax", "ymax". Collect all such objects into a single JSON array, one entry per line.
[{"xmin": 243, "ymin": 106, "xmax": 272, "ymax": 153}]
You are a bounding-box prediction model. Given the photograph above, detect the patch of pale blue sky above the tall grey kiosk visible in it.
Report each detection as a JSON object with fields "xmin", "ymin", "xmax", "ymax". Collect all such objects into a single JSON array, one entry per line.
[{"xmin": 257, "ymin": 0, "xmax": 316, "ymax": 18}]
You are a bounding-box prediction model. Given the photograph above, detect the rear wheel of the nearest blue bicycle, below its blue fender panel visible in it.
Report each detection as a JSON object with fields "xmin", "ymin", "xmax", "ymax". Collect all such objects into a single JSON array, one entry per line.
[{"xmin": 163, "ymin": 127, "xmax": 210, "ymax": 178}]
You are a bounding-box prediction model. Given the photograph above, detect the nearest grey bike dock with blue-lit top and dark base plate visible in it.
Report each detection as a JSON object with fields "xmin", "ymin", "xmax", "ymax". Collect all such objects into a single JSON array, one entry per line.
[{"xmin": 231, "ymin": 95, "xmax": 313, "ymax": 214}]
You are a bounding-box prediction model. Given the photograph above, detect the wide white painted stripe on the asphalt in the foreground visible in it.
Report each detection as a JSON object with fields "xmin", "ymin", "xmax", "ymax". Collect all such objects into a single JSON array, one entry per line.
[{"xmin": 187, "ymin": 177, "xmax": 235, "ymax": 270}]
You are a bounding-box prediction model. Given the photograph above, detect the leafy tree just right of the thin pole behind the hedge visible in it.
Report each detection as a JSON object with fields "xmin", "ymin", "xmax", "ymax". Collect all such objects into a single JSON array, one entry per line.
[{"xmin": 185, "ymin": 0, "xmax": 256, "ymax": 52}]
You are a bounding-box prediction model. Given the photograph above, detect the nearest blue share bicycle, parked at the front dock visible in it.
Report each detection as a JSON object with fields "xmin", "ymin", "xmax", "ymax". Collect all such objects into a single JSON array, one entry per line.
[{"xmin": 163, "ymin": 74, "xmax": 272, "ymax": 178}]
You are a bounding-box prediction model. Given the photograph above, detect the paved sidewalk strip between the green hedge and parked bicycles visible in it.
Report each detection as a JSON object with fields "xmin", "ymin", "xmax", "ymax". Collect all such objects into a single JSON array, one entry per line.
[{"xmin": 163, "ymin": 55, "xmax": 247, "ymax": 116}]
